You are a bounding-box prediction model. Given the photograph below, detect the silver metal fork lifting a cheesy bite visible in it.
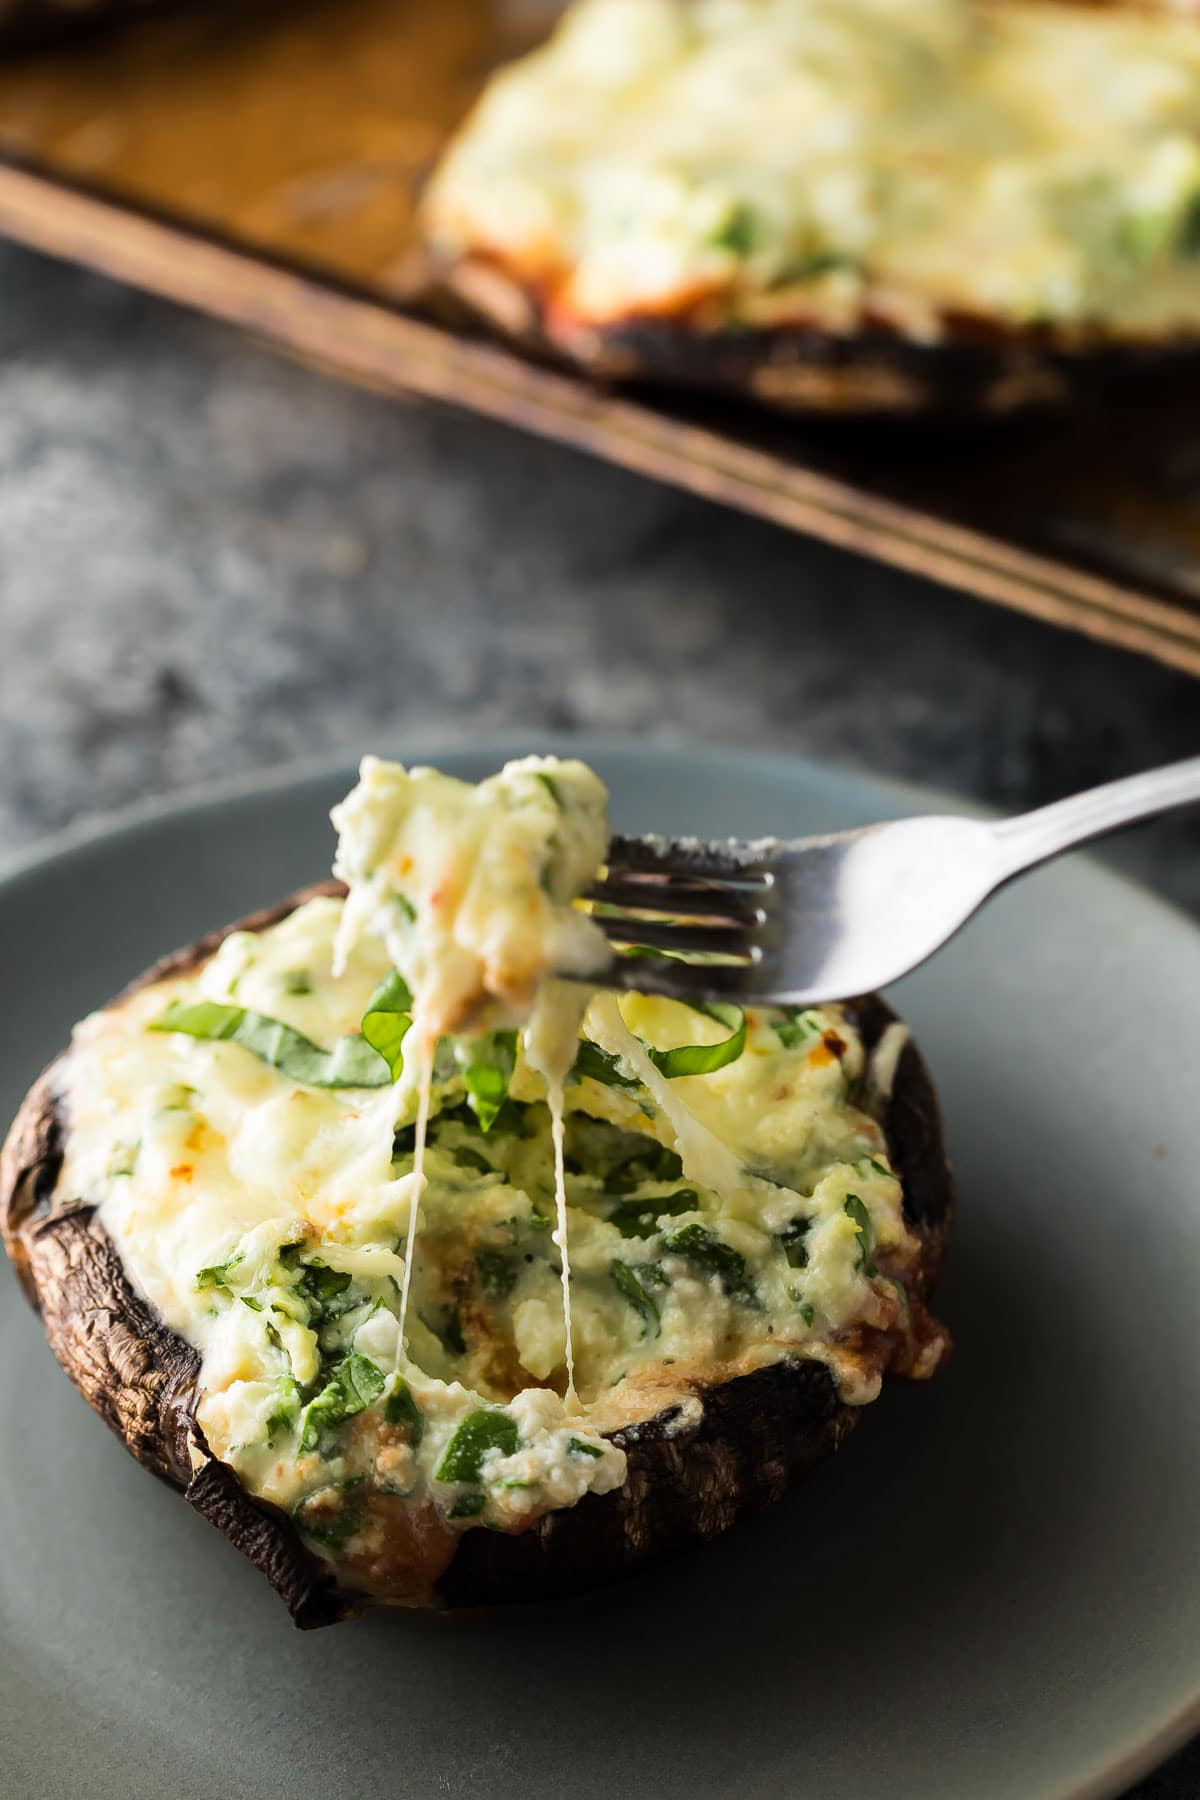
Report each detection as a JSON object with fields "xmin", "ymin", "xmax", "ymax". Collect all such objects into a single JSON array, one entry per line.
[{"xmin": 588, "ymin": 756, "xmax": 1200, "ymax": 1006}]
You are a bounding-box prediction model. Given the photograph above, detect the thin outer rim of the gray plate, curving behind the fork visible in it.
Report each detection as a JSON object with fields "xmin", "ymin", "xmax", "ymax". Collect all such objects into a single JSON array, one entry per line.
[{"xmin": 0, "ymin": 727, "xmax": 1200, "ymax": 1800}]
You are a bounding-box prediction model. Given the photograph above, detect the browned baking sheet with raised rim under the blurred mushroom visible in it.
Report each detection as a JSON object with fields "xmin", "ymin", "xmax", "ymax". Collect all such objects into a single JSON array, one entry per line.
[{"xmin": 0, "ymin": 0, "xmax": 1200, "ymax": 675}]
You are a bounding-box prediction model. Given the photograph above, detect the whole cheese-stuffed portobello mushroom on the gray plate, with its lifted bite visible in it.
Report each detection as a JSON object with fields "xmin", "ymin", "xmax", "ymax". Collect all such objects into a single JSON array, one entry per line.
[{"xmin": 0, "ymin": 758, "xmax": 952, "ymax": 1625}]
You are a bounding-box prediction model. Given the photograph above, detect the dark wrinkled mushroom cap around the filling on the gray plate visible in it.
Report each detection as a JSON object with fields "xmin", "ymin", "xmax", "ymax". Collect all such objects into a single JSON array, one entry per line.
[{"xmin": 0, "ymin": 882, "xmax": 954, "ymax": 1627}]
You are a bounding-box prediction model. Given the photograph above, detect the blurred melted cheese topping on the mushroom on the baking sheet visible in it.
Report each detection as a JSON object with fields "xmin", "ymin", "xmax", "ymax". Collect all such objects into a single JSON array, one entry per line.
[{"xmin": 426, "ymin": 0, "xmax": 1200, "ymax": 340}]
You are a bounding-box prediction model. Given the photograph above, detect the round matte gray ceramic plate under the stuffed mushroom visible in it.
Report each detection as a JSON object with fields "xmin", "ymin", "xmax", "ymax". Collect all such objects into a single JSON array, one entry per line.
[{"xmin": 0, "ymin": 745, "xmax": 1200, "ymax": 1800}]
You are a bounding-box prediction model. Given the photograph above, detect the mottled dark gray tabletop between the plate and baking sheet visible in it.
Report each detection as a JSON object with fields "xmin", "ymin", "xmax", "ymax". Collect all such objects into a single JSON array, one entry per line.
[{"xmin": 0, "ymin": 235, "xmax": 1200, "ymax": 1800}]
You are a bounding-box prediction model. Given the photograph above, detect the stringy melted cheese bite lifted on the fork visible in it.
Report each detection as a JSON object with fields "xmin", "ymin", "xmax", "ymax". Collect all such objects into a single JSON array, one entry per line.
[{"xmin": 333, "ymin": 756, "xmax": 610, "ymax": 1409}]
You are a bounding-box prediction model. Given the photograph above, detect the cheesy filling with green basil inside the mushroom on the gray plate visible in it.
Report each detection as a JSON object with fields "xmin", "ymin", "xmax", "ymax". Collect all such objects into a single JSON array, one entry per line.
[{"xmin": 59, "ymin": 760, "xmax": 943, "ymax": 1602}]
